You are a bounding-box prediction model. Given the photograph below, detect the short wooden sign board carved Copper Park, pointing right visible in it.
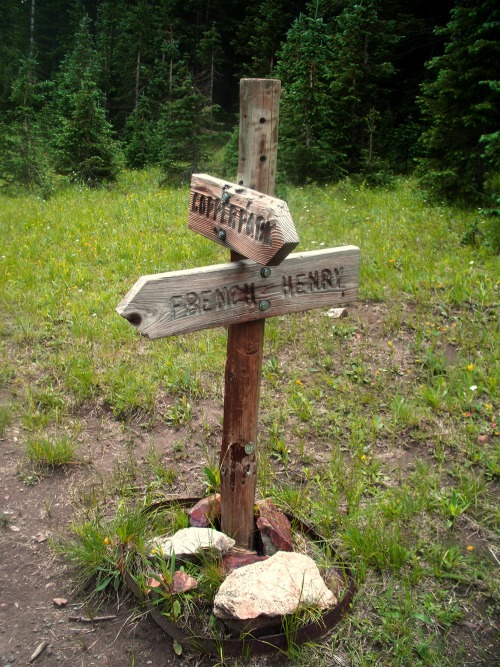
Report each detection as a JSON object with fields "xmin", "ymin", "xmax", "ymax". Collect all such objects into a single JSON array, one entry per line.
[{"xmin": 188, "ymin": 174, "xmax": 299, "ymax": 266}]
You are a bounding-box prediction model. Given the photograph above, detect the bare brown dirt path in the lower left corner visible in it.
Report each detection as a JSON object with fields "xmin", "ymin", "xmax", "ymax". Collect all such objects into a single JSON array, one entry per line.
[{"xmin": 0, "ymin": 415, "xmax": 213, "ymax": 667}]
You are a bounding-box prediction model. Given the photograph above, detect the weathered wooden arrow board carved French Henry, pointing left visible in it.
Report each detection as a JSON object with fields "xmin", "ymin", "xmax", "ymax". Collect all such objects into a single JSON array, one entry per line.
[{"xmin": 116, "ymin": 246, "xmax": 359, "ymax": 338}]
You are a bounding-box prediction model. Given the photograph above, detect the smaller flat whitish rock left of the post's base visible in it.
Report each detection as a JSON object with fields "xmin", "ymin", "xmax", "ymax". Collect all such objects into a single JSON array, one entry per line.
[{"xmin": 148, "ymin": 527, "xmax": 235, "ymax": 560}]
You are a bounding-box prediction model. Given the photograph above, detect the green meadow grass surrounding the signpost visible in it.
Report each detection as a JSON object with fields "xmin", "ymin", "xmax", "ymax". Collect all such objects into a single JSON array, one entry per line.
[{"xmin": 0, "ymin": 172, "xmax": 500, "ymax": 667}]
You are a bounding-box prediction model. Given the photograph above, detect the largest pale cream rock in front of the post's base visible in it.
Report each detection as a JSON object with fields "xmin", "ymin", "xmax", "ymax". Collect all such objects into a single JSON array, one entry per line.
[{"xmin": 214, "ymin": 551, "xmax": 337, "ymax": 632}]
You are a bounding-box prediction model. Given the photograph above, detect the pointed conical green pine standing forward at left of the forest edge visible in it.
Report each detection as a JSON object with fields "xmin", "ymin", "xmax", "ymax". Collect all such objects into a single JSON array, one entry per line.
[{"xmin": 54, "ymin": 17, "xmax": 118, "ymax": 186}]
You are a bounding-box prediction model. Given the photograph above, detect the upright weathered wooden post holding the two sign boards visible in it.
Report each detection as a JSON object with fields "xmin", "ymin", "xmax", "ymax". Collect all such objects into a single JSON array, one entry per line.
[{"xmin": 220, "ymin": 79, "xmax": 282, "ymax": 549}]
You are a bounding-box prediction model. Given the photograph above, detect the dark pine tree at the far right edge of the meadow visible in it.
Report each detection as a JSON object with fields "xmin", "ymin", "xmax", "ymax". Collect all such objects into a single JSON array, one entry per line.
[{"xmin": 420, "ymin": 0, "xmax": 500, "ymax": 200}]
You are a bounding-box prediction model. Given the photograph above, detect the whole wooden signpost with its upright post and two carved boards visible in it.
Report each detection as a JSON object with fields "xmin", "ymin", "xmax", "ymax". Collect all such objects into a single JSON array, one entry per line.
[{"xmin": 117, "ymin": 79, "xmax": 359, "ymax": 548}]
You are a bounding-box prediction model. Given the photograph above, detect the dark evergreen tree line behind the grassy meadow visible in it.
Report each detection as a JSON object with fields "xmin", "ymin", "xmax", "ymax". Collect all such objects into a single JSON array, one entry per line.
[{"xmin": 0, "ymin": 0, "xmax": 500, "ymax": 206}]
